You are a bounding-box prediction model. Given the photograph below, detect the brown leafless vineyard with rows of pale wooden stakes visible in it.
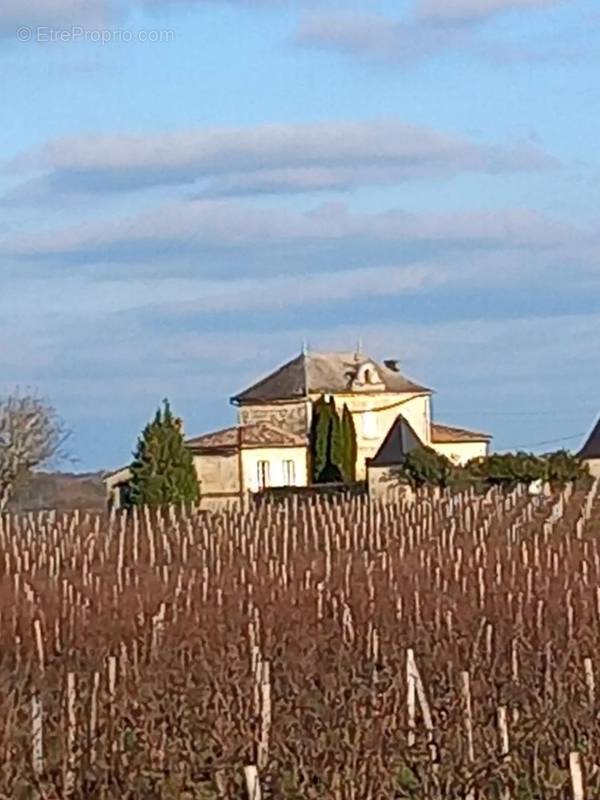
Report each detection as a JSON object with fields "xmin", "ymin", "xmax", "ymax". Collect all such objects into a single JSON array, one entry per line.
[{"xmin": 0, "ymin": 481, "xmax": 600, "ymax": 800}]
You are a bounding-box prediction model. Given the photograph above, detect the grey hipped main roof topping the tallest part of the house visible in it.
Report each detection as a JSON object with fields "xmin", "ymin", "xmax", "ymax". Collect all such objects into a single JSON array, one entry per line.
[{"xmin": 231, "ymin": 353, "xmax": 431, "ymax": 404}]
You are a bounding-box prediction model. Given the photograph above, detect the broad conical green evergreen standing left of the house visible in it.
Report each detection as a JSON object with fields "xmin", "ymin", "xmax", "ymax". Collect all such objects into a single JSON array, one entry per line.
[{"xmin": 130, "ymin": 400, "xmax": 200, "ymax": 507}]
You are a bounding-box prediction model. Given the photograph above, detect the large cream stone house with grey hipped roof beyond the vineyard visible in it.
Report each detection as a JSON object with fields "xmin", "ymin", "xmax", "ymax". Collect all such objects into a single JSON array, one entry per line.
[{"xmin": 106, "ymin": 351, "xmax": 491, "ymax": 507}]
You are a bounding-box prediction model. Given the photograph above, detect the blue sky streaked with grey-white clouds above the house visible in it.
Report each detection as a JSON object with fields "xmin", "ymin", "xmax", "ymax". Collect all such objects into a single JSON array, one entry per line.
[{"xmin": 0, "ymin": 0, "xmax": 600, "ymax": 470}]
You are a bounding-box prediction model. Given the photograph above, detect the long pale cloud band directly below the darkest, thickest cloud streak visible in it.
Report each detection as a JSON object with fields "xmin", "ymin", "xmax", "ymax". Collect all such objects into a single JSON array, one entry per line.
[{"xmin": 0, "ymin": 201, "xmax": 577, "ymax": 261}]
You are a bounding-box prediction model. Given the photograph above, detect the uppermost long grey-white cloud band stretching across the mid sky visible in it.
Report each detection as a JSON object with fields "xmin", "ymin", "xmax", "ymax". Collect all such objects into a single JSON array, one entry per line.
[{"xmin": 6, "ymin": 120, "xmax": 556, "ymax": 196}]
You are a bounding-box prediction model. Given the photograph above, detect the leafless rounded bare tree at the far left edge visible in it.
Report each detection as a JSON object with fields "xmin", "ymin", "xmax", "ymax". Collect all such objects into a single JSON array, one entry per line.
[{"xmin": 0, "ymin": 392, "xmax": 69, "ymax": 512}]
